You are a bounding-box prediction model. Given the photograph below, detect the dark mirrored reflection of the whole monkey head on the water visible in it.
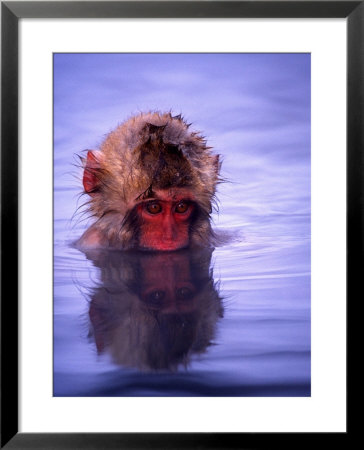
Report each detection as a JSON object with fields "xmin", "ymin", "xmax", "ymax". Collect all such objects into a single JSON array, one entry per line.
[{"xmin": 87, "ymin": 249, "xmax": 223, "ymax": 370}]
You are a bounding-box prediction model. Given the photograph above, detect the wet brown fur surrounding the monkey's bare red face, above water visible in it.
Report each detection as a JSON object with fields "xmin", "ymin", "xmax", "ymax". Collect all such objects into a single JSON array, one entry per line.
[{"xmin": 81, "ymin": 113, "xmax": 220, "ymax": 248}]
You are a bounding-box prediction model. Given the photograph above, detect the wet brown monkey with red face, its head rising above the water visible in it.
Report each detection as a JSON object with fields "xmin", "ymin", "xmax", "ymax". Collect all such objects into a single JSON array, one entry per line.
[{"xmin": 77, "ymin": 113, "xmax": 220, "ymax": 251}]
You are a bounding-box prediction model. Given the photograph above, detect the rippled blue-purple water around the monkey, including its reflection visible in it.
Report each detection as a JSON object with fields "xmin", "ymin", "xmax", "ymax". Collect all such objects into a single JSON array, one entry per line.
[{"xmin": 54, "ymin": 54, "xmax": 311, "ymax": 396}]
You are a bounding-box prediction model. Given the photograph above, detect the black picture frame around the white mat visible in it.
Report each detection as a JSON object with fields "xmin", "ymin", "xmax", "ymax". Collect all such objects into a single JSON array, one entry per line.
[{"xmin": 1, "ymin": 0, "xmax": 358, "ymax": 449}]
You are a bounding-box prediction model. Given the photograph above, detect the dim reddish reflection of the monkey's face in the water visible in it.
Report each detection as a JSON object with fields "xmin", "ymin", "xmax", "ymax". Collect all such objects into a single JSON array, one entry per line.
[{"xmin": 140, "ymin": 253, "xmax": 196, "ymax": 314}]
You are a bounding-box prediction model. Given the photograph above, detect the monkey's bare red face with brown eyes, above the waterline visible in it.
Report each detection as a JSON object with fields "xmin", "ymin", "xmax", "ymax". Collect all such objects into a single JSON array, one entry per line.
[{"xmin": 138, "ymin": 191, "xmax": 195, "ymax": 251}]
